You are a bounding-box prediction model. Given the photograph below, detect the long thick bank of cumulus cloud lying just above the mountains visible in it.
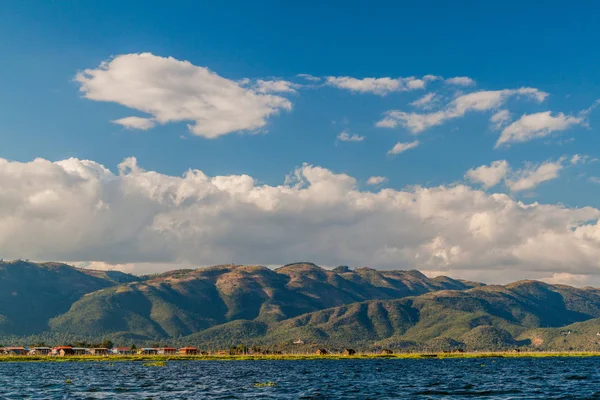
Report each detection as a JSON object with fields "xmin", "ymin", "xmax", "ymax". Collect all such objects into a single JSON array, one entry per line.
[{"xmin": 0, "ymin": 158, "xmax": 600, "ymax": 281}]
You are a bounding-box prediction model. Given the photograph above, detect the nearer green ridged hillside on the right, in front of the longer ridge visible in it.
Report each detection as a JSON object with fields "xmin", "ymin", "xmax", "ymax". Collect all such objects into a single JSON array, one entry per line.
[{"xmin": 188, "ymin": 281, "xmax": 600, "ymax": 350}]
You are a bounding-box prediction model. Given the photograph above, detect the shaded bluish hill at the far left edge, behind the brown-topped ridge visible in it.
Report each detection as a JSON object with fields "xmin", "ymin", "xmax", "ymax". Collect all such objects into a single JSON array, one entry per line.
[{"xmin": 0, "ymin": 261, "xmax": 138, "ymax": 335}]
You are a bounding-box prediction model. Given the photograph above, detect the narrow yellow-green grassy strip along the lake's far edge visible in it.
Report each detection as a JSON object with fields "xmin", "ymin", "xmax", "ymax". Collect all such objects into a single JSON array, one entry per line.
[{"xmin": 0, "ymin": 351, "xmax": 600, "ymax": 362}]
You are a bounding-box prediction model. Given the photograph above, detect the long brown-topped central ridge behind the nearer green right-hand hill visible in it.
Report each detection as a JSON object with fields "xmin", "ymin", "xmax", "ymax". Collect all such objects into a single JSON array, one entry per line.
[{"xmin": 50, "ymin": 263, "xmax": 477, "ymax": 338}]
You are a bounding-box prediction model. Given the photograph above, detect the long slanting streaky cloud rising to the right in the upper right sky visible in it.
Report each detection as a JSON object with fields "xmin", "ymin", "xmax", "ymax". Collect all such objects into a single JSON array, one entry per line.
[{"xmin": 376, "ymin": 87, "xmax": 548, "ymax": 133}]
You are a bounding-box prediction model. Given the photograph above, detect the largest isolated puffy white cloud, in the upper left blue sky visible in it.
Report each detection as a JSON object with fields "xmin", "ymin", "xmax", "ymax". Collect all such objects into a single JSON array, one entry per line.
[{"xmin": 75, "ymin": 53, "xmax": 292, "ymax": 138}]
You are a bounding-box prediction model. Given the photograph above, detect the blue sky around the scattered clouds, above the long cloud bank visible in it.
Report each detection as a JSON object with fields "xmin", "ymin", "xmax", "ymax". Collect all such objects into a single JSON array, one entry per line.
[{"xmin": 0, "ymin": 1, "xmax": 600, "ymax": 282}]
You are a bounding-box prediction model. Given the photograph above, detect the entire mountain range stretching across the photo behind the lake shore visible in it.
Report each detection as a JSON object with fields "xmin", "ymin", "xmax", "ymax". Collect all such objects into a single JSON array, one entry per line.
[{"xmin": 0, "ymin": 260, "xmax": 600, "ymax": 350}]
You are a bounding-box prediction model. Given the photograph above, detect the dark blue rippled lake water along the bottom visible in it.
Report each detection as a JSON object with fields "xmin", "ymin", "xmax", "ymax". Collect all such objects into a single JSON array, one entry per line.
[{"xmin": 0, "ymin": 358, "xmax": 600, "ymax": 399}]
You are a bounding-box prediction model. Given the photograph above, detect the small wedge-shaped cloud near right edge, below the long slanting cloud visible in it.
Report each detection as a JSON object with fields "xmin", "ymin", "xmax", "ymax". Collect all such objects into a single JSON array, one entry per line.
[{"xmin": 496, "ymin": 111, "xmax": 585, "ymax": 147}]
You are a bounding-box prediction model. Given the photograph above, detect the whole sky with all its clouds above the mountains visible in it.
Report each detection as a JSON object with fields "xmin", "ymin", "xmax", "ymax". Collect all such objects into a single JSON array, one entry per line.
[{"xmin": 0, "ymin": 0, "xmax": 600, "ymax": 286}]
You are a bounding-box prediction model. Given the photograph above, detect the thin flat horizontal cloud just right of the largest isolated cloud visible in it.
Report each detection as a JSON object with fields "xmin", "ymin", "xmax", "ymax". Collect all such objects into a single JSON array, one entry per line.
[{"xmin": 326, "ymin": 76, "xmax": 426, "ymax": 96}]
